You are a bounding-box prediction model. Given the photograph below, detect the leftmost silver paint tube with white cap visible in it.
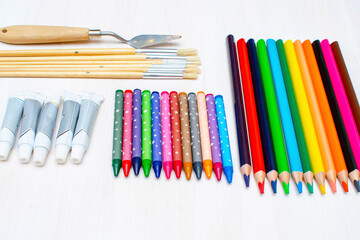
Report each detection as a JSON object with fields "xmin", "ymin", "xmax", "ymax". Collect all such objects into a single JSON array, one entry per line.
[{"xmin": 0, "ymin": 92, "xmax": 24, "ymax": 161}]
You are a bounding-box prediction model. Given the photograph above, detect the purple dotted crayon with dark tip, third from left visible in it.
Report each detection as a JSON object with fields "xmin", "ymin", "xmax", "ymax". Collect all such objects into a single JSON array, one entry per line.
[{"xmin": 131, "ymin": 89, "xmax": 142, "ymax": 176}]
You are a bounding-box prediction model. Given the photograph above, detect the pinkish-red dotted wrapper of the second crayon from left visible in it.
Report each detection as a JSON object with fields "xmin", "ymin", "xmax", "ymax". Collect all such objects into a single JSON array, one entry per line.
[{"xmin": 122, "ymin": 90, "xmax": 133, "ymax": 161}]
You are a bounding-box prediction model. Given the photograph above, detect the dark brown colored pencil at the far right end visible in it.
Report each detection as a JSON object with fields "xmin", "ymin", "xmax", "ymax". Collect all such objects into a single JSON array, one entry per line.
[{"xmin": 330, "ymin": 41, "xmax": 360, "ymax": 134}]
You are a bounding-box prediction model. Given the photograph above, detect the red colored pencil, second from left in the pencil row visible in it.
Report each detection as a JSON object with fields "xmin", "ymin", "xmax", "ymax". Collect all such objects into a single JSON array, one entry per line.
[{"xmin": 237, "ymin": 38, "xmax": 265, "ymax": 193}]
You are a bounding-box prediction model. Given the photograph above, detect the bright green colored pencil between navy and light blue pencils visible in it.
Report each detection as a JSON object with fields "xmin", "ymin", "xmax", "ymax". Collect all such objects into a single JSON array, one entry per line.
[{"xmin": 257, "ymin": 39, "xmax": 290, "ymax": 194}]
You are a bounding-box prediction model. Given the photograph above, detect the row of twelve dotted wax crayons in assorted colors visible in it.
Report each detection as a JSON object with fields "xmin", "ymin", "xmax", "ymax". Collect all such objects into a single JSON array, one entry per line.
[{"xmin": 112, "ymin": 89, "xmax": 233, "ymax": 183}]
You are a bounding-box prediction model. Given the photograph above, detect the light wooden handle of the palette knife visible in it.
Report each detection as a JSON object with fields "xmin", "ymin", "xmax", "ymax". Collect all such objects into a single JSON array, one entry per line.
[{"xmin": 0, "ymin": 25, "xmax": 89, "ymax": 44}]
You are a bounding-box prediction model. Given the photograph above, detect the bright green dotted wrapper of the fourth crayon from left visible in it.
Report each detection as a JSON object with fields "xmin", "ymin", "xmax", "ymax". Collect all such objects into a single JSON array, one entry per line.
[{"xmin": 141, "ymin": 90, "xmax": 152, "ymax": 160}]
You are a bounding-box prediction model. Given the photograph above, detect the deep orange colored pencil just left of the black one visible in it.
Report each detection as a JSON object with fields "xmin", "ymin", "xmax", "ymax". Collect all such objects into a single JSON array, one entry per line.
[{"xmin": 303, "ymin": 40, "xmax": 348, "ymax": 192}]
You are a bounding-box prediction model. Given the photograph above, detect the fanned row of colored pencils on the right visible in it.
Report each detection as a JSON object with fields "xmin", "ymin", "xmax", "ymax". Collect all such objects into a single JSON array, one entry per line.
[{"xmin": 227, "ymin": 35, "xmax": 360, "ymax": 194}]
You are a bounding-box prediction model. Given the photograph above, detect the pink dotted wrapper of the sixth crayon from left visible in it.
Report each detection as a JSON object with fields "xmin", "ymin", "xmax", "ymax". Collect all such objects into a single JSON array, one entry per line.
[{"xmin": 161, "ymin": 92, "xmax": 172, "ymax": 163}]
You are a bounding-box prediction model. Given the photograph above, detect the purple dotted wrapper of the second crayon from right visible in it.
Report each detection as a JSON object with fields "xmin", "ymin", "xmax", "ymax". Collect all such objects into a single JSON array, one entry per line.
[{"xmin": 206, "ymin": 94, "xmax": 222, "ymax": 163}]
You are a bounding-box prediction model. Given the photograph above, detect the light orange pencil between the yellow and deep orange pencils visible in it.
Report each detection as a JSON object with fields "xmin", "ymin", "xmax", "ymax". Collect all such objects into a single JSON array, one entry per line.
[{"xmin": 294, "ymin": 40, "xmax": 336, "ymax": 192}]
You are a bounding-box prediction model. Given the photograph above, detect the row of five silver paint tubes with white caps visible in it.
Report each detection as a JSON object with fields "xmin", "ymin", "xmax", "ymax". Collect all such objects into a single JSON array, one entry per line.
[{"xmin": 0, "ymin": 92, "xmax": 103, "ymax": 166}]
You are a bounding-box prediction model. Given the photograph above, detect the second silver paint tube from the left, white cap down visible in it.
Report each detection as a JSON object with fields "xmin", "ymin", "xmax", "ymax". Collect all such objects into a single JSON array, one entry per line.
[{"xmin": 19, "ymin": 92, "xmax": 45, "ymax": 163}]
